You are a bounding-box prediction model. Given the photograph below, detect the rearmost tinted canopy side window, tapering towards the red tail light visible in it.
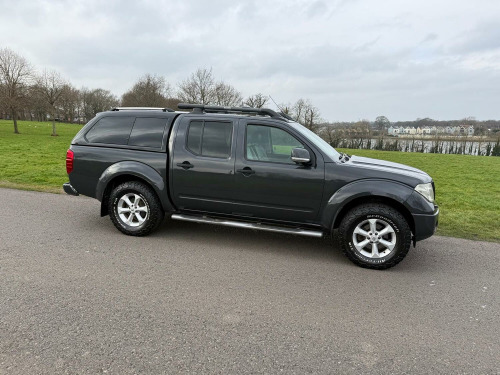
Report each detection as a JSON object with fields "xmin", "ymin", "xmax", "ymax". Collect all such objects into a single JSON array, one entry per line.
[{"xmin": 85, "ymin": 116, "xmax": 134, "ymax": 145}]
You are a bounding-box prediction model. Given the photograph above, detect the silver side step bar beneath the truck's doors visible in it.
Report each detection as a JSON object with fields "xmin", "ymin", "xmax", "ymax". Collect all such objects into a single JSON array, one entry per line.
[{"xmin": 171, "ymin": 214, "xmax": 323, "ymax": 237}]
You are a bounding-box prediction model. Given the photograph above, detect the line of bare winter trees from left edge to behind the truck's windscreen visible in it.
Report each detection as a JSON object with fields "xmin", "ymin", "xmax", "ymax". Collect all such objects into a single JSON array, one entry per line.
[{"xmin": 0, "ymin": 48, "xmax": 321, "ymax": 136}]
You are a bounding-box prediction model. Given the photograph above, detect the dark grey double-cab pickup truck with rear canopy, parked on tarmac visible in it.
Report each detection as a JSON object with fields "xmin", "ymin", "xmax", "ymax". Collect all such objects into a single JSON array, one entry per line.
[{"xmin": 63, "ymin": 104, "xmax": 439, "ymax": 269}]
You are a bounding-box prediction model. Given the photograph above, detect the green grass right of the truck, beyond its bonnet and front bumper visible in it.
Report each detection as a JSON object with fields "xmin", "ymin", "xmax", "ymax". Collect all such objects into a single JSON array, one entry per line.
[{"xmin": 340, "ymin": 149, "xmax": 500, "ymax": 242}]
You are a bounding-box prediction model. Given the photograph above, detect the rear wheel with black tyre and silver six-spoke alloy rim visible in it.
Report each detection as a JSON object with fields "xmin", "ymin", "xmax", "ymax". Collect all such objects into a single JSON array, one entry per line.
[{"xmin": 108, "ymin": 181, "xmax": 164, "ymax": 236}]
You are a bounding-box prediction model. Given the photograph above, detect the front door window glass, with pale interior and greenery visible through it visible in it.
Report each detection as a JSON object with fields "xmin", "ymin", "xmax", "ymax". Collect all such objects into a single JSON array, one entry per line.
[{"xmin": 246, "ymin": 125, "xmax": 304, "ymax": 164}]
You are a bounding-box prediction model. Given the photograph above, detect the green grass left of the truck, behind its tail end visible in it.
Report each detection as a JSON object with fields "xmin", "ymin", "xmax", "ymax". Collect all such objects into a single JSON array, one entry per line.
[{"xmin": 0, "ymin": 120, "xmax": 81, "ymax": 192}]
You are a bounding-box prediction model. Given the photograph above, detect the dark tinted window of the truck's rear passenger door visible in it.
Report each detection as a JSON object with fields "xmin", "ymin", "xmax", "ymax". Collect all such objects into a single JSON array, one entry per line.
[{"xmin": 187, "ymin": 121, "xmax": 233, "ymax": 158}]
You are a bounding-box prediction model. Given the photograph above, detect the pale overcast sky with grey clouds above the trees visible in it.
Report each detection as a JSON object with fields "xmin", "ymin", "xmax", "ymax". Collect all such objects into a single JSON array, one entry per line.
[{"xmin": 0, "ymin": 0, "xmax": 500, "ymax": 121}]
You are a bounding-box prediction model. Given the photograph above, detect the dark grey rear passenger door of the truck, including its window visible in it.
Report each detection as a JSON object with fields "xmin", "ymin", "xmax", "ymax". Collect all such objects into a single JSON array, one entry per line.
[{"xmin": 171, "ymin": 115, "xmax": 236, "ymax": 214}]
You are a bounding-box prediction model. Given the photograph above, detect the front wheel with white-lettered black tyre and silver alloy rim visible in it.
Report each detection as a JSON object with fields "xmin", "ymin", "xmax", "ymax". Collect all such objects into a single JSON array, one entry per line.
[{"xmin": 339, "ymin": 203, "xmax": 411, "ymax": 270}]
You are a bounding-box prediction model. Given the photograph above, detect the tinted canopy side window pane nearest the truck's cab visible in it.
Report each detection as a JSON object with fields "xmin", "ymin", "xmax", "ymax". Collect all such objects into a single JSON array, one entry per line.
[{"xmin": 128, "ymin": 117, "xmax": 167, "ymax": 148}]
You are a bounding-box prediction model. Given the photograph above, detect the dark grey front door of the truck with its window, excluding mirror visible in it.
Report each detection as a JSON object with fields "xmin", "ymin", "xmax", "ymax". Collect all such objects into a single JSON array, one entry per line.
[{"xmin": 234, "ymin": 118, "xmax": 325, "ymax": 223}]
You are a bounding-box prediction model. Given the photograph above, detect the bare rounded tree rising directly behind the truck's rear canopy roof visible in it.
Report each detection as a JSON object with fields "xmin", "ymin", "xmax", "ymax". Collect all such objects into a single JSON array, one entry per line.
[{"xmin": 122, "ymin": 74, "xmax": 171, "ymax": 107}]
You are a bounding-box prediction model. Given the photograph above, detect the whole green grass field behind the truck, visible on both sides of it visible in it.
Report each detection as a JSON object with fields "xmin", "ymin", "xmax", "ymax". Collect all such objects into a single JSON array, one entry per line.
[{"xmin": 0, "ymin": 120, "xmax": 500, "ymax": 242}]
